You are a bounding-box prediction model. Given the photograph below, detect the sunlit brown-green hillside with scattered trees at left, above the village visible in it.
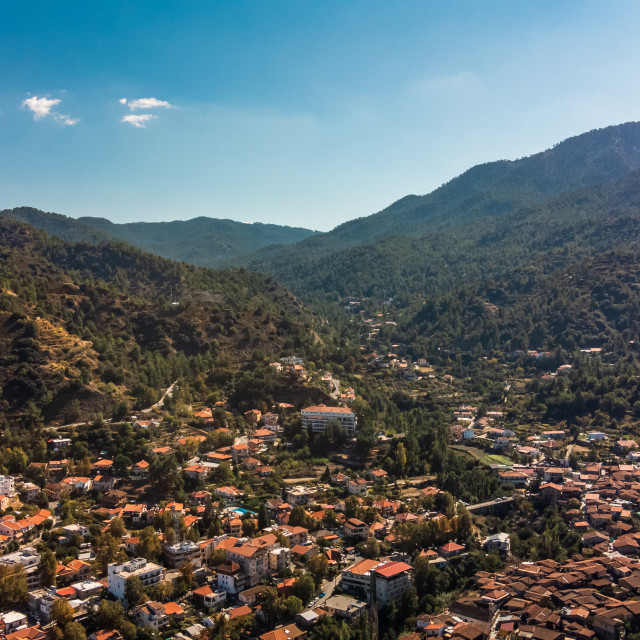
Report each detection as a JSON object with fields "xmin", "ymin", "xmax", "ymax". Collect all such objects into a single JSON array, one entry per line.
[{"xmin": 0, "ymin": 219, "xmax": 331, "ymax": 419}]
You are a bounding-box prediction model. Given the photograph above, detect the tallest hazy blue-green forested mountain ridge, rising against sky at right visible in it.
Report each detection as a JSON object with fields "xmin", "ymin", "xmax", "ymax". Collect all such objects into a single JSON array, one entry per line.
[{"xmin": 251, "ymin": 123, "xmax": 640, "ymax": 296}]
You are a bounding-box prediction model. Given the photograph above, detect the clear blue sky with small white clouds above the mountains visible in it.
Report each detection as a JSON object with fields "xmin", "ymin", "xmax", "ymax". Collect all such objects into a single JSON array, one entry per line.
[{"xmin": 0, "ymin": 0, "xmax": 640, "ymax": 230}]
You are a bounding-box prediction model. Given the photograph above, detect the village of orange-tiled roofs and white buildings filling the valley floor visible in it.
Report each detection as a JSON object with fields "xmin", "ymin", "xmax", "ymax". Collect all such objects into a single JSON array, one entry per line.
[{"xmin": 0, "ymin": 354, "xmax": 640, "ymax": 640}]
